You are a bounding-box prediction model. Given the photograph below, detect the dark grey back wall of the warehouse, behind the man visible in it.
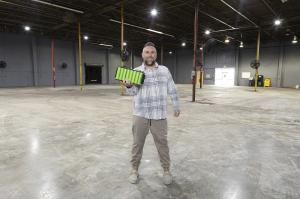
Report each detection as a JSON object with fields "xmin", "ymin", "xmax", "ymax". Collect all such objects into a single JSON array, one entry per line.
[{"xmin": 0, "ymin": 33, "xmax": 300, "ymax": 87}]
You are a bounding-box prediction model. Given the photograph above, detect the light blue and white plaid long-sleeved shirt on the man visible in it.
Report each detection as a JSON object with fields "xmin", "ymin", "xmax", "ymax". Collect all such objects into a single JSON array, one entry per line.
[{"xmin": 126, "ymin": 63, "xmax": 179, "ymax": 120}]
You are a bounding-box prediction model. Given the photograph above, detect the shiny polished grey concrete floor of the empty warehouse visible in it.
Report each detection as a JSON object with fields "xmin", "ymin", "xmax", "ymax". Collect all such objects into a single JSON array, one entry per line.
[{"xmin": 0, "ymin": 85, "xmax": 300, "ymax": 199}]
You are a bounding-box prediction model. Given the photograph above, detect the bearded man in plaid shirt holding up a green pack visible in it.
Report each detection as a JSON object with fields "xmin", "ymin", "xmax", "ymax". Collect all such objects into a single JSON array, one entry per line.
[{"xmin": 121, "ymin": 42, "xmax": 180, "ymax": 185}]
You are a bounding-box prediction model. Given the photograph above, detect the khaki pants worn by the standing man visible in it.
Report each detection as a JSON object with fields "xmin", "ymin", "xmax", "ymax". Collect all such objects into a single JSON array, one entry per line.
[{"xmin": 131, "ymin": 116, "xmax": 170, "ymax": 171}]
